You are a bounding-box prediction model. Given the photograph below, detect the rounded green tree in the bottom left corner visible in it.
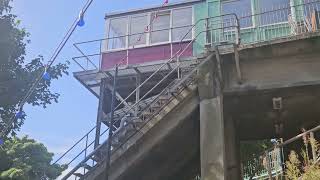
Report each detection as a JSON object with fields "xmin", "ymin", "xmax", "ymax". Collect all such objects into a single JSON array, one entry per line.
[{"xmin": 0, "ymin": 136, "xmax": 67, "ymax": 180}]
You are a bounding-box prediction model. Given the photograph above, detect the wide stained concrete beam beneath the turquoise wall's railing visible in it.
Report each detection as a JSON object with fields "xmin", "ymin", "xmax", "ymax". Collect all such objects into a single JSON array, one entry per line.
[{"xmin": 223, "ymin": 37, "xmax": 320, "ymax": 92}]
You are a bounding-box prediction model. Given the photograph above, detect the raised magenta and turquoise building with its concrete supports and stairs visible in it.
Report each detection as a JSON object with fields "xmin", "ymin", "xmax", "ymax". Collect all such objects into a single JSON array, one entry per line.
[{"xmin": 56, "ymin": 0, "xmax": 320, "ymax": 180}]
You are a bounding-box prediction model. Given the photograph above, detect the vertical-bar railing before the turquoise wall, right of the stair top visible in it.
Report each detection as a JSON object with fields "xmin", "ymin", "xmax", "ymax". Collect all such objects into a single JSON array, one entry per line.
[{"xmin": 239, "ymin": 0, "xmax": 320, "ymax": 44}]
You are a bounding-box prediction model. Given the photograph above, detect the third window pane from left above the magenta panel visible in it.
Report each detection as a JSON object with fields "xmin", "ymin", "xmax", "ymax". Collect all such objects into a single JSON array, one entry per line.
[{"xmin": 151, "ymin": 11, "xmax": 170, "ymax": 44}]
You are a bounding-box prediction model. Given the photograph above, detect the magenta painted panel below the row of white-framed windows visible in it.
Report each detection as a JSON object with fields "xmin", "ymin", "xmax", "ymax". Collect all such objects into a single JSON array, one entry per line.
[{"xmin": 101, "ymin": 42, "xmax": 193, "ymax": 69}]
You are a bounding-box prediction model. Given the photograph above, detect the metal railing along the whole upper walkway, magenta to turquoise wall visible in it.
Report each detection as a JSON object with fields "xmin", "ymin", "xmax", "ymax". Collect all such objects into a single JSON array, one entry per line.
[{"xmin": 73, "ymin": 0, "xmax": 320, "ymax": 71}]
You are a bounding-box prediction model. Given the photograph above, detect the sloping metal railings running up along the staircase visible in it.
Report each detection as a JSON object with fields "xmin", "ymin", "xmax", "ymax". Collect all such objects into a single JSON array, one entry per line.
[{"xmin": 59, "ymin": 14, "xmax": 239, "ymax": 179}]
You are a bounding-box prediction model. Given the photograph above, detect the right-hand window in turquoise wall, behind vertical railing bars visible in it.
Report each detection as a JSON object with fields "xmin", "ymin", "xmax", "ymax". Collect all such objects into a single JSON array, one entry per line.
[{"xmin": 258, "ymin": 0, "xmax": 291, "ymax": 25}]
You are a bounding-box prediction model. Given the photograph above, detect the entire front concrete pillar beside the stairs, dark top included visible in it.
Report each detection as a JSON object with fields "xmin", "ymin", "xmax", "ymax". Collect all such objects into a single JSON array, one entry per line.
[{"xmin": 198, "ymin": 55, "xmax": 226, "ymax": 180}]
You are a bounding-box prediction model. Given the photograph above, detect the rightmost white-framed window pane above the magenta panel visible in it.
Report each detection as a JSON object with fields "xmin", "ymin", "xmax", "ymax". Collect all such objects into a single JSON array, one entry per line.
[{"xmin": 172, "ymin": 8, "xmax": 192, "ymax": 41}]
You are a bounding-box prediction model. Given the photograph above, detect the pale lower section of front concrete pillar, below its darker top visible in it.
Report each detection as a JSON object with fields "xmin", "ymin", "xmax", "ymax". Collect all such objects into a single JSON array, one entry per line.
[{"xmin": 200, "ymin": 96, "xmax": 226, "ymax": 180}]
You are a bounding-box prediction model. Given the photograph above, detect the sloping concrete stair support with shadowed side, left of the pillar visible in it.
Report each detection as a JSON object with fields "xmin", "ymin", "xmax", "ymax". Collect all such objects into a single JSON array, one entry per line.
[{"xmin": 86, "ymin": 89, "xmax": 199, "ymax": 180}]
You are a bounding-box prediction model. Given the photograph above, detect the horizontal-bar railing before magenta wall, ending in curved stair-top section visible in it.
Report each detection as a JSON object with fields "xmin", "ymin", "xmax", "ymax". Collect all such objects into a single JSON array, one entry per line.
[{"xmin": 72, "ymin": 13, "xmax": 239, "ymax": 71}]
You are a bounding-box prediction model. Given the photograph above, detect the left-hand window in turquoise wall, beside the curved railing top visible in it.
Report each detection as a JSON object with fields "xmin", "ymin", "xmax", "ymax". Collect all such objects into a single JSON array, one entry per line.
[{"xmin": 222, "ymin": 0, "xmax": 252, "ymax": 28}]
